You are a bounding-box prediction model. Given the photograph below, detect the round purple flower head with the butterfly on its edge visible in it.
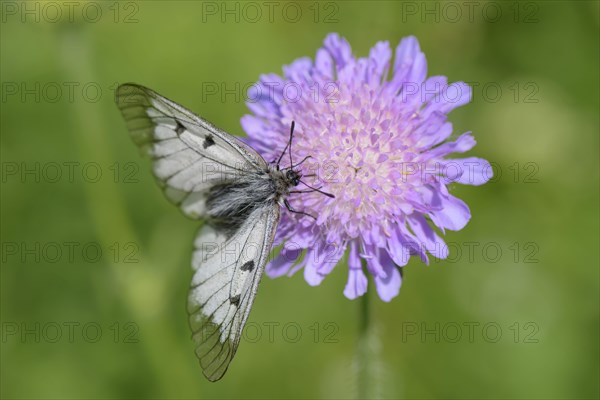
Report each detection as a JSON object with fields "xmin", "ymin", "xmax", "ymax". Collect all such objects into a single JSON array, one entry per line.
[{"xmin": 241, "ymin": 34, "xmax": 492, "ymax": 301}]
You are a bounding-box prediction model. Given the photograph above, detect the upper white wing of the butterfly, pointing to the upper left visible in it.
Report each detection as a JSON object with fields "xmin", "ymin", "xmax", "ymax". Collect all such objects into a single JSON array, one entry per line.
[{"xmin": 117, "ymin": 84, "xmax": 267, "ymax": 218}]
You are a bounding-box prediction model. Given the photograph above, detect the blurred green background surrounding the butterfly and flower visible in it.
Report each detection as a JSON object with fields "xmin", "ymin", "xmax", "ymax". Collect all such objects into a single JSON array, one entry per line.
[{"xmin": 0, "ymin": 1, "xmax": 599, "ymax": 399}]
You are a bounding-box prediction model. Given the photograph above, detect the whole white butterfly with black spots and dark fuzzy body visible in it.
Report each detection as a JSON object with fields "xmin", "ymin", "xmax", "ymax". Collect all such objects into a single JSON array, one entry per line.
[{"xmin": 116, "ymin": 84, "xmax": 334, "ymax": 381}]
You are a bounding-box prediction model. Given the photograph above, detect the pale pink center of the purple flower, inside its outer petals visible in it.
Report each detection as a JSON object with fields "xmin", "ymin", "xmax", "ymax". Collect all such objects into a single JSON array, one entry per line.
[{"xmin": 290, "ymin": 81, "xmax": 414, "ymax": 237}]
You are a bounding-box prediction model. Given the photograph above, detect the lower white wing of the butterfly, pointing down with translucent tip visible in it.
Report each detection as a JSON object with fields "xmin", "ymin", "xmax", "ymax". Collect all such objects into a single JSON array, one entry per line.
[{"xmin": 188, "ymin": 204, "xmax": 279, "ymax": 381}]
